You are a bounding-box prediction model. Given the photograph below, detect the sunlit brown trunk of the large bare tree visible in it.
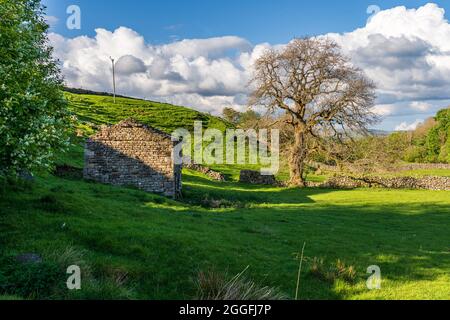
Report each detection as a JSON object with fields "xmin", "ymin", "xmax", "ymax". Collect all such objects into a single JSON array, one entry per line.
[{"xmin": 289, "ymin": 127, "xmax": 306, "ymax": 188}]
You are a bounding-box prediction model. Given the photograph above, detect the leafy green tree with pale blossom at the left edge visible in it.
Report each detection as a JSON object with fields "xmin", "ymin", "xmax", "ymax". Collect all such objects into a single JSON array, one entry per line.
[{"xmin": 0, "ymin": 0, "xmax": 68, "ymax": 174}]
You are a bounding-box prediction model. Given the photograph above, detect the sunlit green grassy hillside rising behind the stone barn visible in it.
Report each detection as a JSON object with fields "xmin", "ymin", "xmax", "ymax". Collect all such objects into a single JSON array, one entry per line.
[{"xmin": 65, "ymin": 88, "xmax": 233, "ymax": 134}]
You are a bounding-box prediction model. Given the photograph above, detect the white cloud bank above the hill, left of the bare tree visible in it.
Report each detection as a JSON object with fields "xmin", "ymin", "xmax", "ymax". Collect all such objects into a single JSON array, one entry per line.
[{"xmin": 50, "ymin": 27, "xmax": 260, "ymax": 114}]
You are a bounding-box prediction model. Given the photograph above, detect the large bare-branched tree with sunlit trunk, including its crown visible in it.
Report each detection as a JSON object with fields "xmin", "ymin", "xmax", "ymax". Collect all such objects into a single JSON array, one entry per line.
[{"xmin": 250, "ymin": 38, "xmax": 378, "ymax": 186}]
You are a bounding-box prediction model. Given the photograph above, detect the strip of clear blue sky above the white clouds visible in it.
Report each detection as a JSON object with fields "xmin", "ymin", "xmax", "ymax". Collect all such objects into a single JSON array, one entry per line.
[{"xmin": 43, "ymin": 0, "xmax": 450, "ymax": 44}]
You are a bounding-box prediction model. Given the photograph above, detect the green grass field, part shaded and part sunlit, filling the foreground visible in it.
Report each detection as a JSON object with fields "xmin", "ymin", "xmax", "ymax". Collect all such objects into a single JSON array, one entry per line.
[{"xmin": 0, "ymin": 95, "xmax": 450, "ymax": 299}]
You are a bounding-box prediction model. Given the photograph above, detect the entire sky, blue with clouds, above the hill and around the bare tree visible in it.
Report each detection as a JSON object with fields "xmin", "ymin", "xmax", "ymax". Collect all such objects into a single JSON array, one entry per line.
[{"xmin": 43, "ymin": 0, "xmax": 450, "ymax": 130}]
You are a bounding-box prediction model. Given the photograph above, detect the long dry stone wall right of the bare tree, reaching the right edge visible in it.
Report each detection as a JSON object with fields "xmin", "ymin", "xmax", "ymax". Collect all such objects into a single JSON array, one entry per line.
[{"xmin": 319, "ymin": 176, "xmax": 450, "ymax": 190}]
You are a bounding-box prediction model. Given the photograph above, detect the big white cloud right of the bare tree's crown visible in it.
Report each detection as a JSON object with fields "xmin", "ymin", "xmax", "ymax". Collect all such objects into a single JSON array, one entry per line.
[{"xmin": 327, "ymin": 3, "xmax": 450, "ymax": 122}]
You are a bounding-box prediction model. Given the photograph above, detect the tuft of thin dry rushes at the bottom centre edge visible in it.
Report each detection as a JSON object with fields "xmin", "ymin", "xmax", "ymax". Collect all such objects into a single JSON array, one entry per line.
[{"xmin": 197, "ymin": 267, "xmax": 286, "ymax": 300}]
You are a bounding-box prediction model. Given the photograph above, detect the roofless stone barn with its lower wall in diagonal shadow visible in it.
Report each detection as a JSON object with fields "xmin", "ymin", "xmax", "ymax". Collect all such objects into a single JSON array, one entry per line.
[{"xmin": 83, "ymin": 119, "xmax": 182, "ymax": 198}]
